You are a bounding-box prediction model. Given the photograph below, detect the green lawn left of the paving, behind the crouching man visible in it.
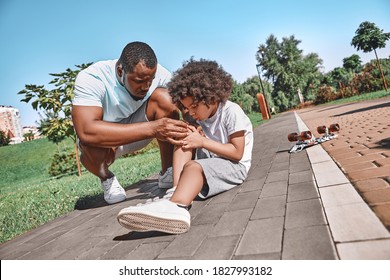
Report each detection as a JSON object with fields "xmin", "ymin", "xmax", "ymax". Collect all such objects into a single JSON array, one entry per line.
[{"xmin": 0, "ymin": 139, "xmax": 160, "ymax": 243}]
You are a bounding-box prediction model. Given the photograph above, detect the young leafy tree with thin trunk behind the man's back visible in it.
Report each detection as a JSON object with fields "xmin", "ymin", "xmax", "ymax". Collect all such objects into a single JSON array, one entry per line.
[{"xmin": 18, "ymin": 63, "xmax": 92, "ymax": 175}]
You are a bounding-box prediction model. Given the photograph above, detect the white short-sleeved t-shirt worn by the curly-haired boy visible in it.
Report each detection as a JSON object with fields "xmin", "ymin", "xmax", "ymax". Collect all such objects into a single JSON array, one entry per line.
[{"xmin": 198, "ymin": 100, "xmax": 253, "ymax": 172}]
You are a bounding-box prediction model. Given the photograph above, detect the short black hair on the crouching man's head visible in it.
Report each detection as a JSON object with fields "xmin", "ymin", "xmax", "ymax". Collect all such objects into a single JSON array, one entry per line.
[{"xmin": 119, "ymin": 42, "xmax": 157, "ymax": 73}]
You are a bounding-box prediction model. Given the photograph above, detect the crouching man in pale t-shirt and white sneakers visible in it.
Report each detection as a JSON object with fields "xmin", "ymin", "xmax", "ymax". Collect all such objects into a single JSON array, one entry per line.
[{"xmin": 72, "ymin": 42, "xmax": 187, "ymax": 204}]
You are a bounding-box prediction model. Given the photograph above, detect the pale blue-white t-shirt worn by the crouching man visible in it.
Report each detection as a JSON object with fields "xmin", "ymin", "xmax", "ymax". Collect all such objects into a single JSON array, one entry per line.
[{"xmin": 72, "ymin": 59, "xmax": 172, "ymax": 122}]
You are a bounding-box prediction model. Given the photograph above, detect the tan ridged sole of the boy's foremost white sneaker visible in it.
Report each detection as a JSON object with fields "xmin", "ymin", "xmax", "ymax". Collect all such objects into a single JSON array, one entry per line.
[{"xmin": 118, "ymin": 213, "xmax": 190, "ymax": 234}]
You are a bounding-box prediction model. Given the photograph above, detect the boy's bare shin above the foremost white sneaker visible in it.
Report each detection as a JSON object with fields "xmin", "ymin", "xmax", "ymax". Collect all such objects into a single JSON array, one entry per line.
[{"xmin": 170, "ymin": 160, "xmax": 206, "ymax": 206}]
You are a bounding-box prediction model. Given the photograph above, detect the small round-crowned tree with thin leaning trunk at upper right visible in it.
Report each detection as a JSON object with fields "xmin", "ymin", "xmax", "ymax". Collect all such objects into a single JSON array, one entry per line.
[{"xmin": 351, "ymin": 21, "xmax": 390, "ymax": 92}]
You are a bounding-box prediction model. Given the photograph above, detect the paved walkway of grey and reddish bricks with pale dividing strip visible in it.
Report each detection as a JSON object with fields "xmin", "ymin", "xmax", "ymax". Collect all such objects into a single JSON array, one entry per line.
[{"xmin": 0, "ymin": 98, "xmax": 390, "ymax": 260}]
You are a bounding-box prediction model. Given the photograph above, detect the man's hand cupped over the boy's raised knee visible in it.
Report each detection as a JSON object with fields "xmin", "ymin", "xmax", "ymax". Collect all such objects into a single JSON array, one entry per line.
[{"xmin": 155, "ymin": 118, "xmax": 188, "ymax": 146}]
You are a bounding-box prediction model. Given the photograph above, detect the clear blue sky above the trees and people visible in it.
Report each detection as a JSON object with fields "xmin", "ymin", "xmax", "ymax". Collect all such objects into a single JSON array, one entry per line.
[{"xmin": 0, "ymin": 0, "xmax": 390, "ymax": 125}]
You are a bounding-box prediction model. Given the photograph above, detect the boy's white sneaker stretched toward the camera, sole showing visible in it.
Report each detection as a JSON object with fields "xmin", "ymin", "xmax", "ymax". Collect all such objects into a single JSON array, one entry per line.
[{"xmin": 117, "ymin": 199, "xmax": 191, "ymax": 234}]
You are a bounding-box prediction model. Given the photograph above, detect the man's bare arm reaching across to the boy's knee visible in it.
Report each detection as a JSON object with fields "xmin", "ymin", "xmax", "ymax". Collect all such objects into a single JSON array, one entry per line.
[{"xmin": 72, "ymin": 105, "xmax": 187, "ymax": 147}]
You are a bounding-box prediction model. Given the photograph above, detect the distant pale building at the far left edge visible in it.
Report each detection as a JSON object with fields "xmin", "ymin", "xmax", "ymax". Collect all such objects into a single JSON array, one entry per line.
[{"xmin": 0, "ymin": 105, "xmax": 23, "ymax": 144}]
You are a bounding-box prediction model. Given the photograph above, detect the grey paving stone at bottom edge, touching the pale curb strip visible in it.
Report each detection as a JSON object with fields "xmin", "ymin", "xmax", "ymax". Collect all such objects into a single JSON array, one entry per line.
[{"xmin": 282, "ymin": 225, "xmax": 337, "ymax": 260}]
